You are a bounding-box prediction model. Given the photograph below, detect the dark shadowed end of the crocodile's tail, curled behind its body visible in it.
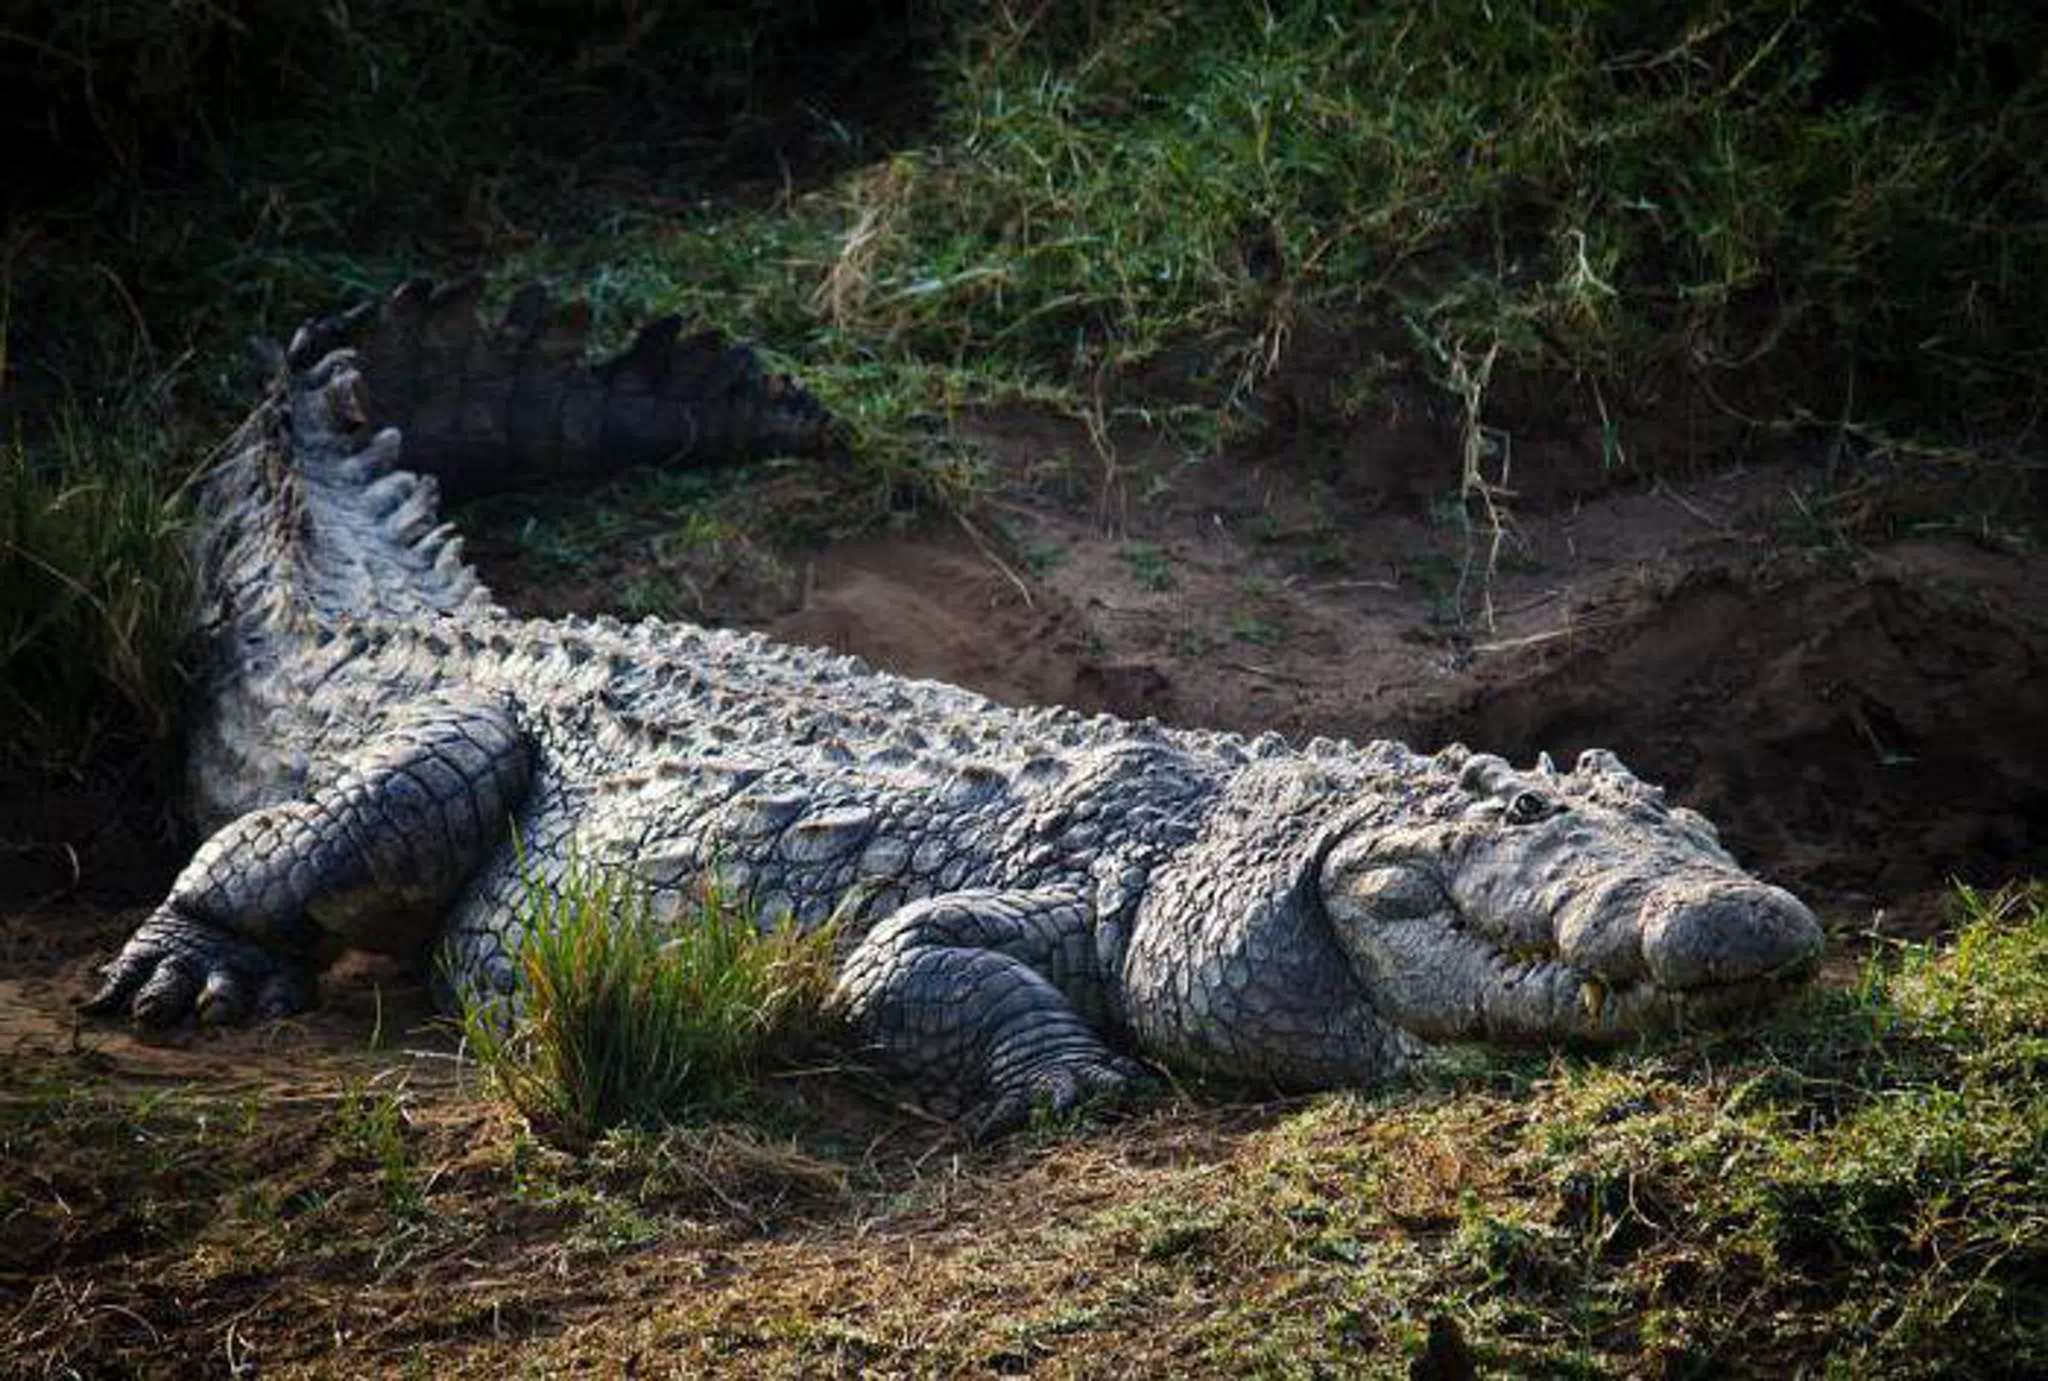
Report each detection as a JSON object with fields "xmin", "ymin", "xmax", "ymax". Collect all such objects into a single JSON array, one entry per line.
[{"xmin": 287, "ymin": 277, "xmax": 846, "ymax": 500}]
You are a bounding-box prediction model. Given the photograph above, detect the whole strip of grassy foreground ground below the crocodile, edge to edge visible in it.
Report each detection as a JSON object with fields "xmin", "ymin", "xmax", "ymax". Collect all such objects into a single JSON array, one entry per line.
[{"xmin": 0, "ymin": 876, "xmax": 2048, "ymax": 1377}]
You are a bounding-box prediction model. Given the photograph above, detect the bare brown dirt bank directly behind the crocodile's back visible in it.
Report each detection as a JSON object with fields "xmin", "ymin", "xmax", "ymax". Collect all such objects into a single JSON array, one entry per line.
[{"xmin": 452, "ymin": 412, "xmax": 2048, "ymax": 932}]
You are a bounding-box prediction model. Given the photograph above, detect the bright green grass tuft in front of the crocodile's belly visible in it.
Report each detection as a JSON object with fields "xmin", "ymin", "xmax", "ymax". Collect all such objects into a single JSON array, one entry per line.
[{"xmin": 461, "ymin": 861, "xmax": 834, "ymax": 1147}]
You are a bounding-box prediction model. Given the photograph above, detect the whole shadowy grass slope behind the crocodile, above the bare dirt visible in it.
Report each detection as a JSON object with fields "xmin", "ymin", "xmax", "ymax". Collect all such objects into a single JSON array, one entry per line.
[{"xmin": 0, "ymin": 0, "xmax": 2048, "ymax": 774}]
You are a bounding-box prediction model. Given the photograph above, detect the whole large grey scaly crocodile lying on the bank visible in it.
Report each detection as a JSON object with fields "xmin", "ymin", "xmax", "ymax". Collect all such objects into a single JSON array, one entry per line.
[{"xmin": 84, "ymin": 285, "xmax": 1823, "ymax": 1135}]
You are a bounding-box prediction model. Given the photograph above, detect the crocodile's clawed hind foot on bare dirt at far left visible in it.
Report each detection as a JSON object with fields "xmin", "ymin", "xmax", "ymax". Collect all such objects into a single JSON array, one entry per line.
[{"xmin": 78, "ymin": 910, "xmax": 313, "ymax": 1027}]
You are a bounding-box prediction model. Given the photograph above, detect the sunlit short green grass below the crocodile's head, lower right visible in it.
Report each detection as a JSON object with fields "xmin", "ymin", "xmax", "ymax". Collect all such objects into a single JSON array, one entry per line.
[{"xmin": 1114, "ymin": 887, "xmax": 2048, "ymax": 1377}]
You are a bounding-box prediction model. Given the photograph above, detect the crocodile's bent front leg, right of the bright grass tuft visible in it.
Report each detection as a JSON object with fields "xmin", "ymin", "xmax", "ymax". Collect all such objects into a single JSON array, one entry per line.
[{"xmin": 834, "ymin": 889, "xmax": 1149, "ymax": 1141}]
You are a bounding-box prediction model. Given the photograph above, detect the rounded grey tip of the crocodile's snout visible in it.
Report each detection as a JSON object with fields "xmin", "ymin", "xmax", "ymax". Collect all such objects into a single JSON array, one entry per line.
[{"xmin": 1642, "ymin": 877, "xmax": 1823, "ymax": 992}]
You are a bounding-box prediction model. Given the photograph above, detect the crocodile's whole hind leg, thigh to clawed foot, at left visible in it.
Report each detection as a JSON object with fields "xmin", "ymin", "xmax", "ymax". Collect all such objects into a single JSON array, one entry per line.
[{"xmin": 82, "ymin": 699, "xmax": 528, "ymax": 1027}]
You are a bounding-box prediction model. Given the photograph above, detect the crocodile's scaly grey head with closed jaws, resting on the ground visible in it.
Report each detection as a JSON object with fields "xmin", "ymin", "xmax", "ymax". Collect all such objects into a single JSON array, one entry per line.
[{"xmin": 1317, "ymin": 746, "xmax": 1821, "ymax": 1041}]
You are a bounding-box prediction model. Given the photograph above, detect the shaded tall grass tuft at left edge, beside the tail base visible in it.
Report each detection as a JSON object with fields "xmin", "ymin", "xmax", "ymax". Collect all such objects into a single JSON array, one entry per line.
[{"xmin": 0, "ymin": 412, "xmax": 193, "ymax": 772}]
